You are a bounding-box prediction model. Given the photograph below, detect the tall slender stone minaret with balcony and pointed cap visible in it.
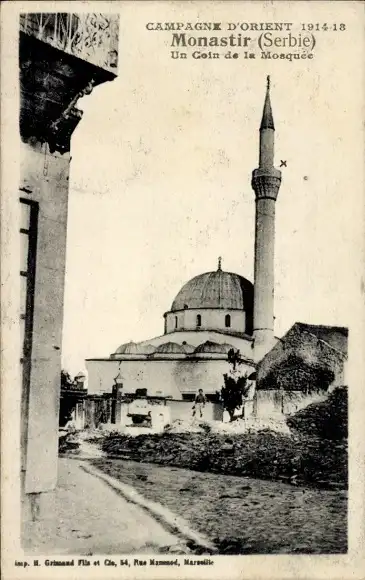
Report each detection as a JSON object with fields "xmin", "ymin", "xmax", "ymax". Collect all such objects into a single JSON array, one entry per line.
[{"xmin": 252, "ymin": 76, "xmax": 281, "ymax": 361}]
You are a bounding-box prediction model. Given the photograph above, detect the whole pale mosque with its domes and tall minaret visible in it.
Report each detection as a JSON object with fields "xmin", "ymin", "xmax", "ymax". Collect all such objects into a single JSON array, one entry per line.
[{"xmin": 86, "ymin": 77, "xmax": 342, "ymax": 402}]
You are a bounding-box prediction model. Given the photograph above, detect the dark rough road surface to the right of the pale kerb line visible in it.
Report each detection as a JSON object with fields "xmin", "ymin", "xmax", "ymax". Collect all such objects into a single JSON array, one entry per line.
[{"xmin": 92, "ymin": 458, "xmax": 347, "ymax": 554}]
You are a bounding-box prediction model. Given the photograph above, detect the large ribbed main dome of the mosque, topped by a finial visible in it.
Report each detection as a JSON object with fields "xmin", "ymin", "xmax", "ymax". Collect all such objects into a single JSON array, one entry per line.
[{"xmin": 171, "ymin": 267, "xmax": 253, "ymax": 312}]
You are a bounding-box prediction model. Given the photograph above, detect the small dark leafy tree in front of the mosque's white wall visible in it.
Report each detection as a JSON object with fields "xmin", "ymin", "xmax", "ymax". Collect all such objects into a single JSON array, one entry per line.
[{"xmin": 219, "ymin": 348, "xmax": 250, "ymax": 421}]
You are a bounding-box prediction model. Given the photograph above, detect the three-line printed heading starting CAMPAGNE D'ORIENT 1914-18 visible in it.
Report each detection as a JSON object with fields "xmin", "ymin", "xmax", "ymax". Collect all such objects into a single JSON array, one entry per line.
[{"xmin": 146, "ymin": 22, "xmax": 346, "ymax": 61}]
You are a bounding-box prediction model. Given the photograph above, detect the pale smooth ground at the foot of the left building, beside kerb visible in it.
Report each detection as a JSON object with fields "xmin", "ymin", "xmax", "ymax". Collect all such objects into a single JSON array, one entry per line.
[{"xmin": 23, "ymin": 458, "xmax": 189, "ymax": 555}]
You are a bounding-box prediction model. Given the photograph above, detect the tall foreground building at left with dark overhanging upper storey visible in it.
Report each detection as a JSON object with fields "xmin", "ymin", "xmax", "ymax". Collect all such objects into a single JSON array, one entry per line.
[{"xmin": 19, "ymin": 13, "xmax": 119, "ymax": 509}]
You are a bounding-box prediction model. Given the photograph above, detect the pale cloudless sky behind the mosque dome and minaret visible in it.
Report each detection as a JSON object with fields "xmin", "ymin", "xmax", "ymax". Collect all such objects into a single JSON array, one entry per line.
[{"xmin": 59, "ymin": 2, "xmax": 364, "ymax": 374}]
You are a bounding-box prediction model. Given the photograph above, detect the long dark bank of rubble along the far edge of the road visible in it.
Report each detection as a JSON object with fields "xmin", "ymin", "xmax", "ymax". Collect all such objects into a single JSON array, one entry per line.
[{"xmin": 102, "ymin": 424, "xmax": 347, "ymax": 489}]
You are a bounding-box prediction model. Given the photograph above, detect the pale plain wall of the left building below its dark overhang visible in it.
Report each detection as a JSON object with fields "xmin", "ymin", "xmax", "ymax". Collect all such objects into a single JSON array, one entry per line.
[{"xmin": 20, "ymin": 142, "xmax": 70, "ymax": 493}]
